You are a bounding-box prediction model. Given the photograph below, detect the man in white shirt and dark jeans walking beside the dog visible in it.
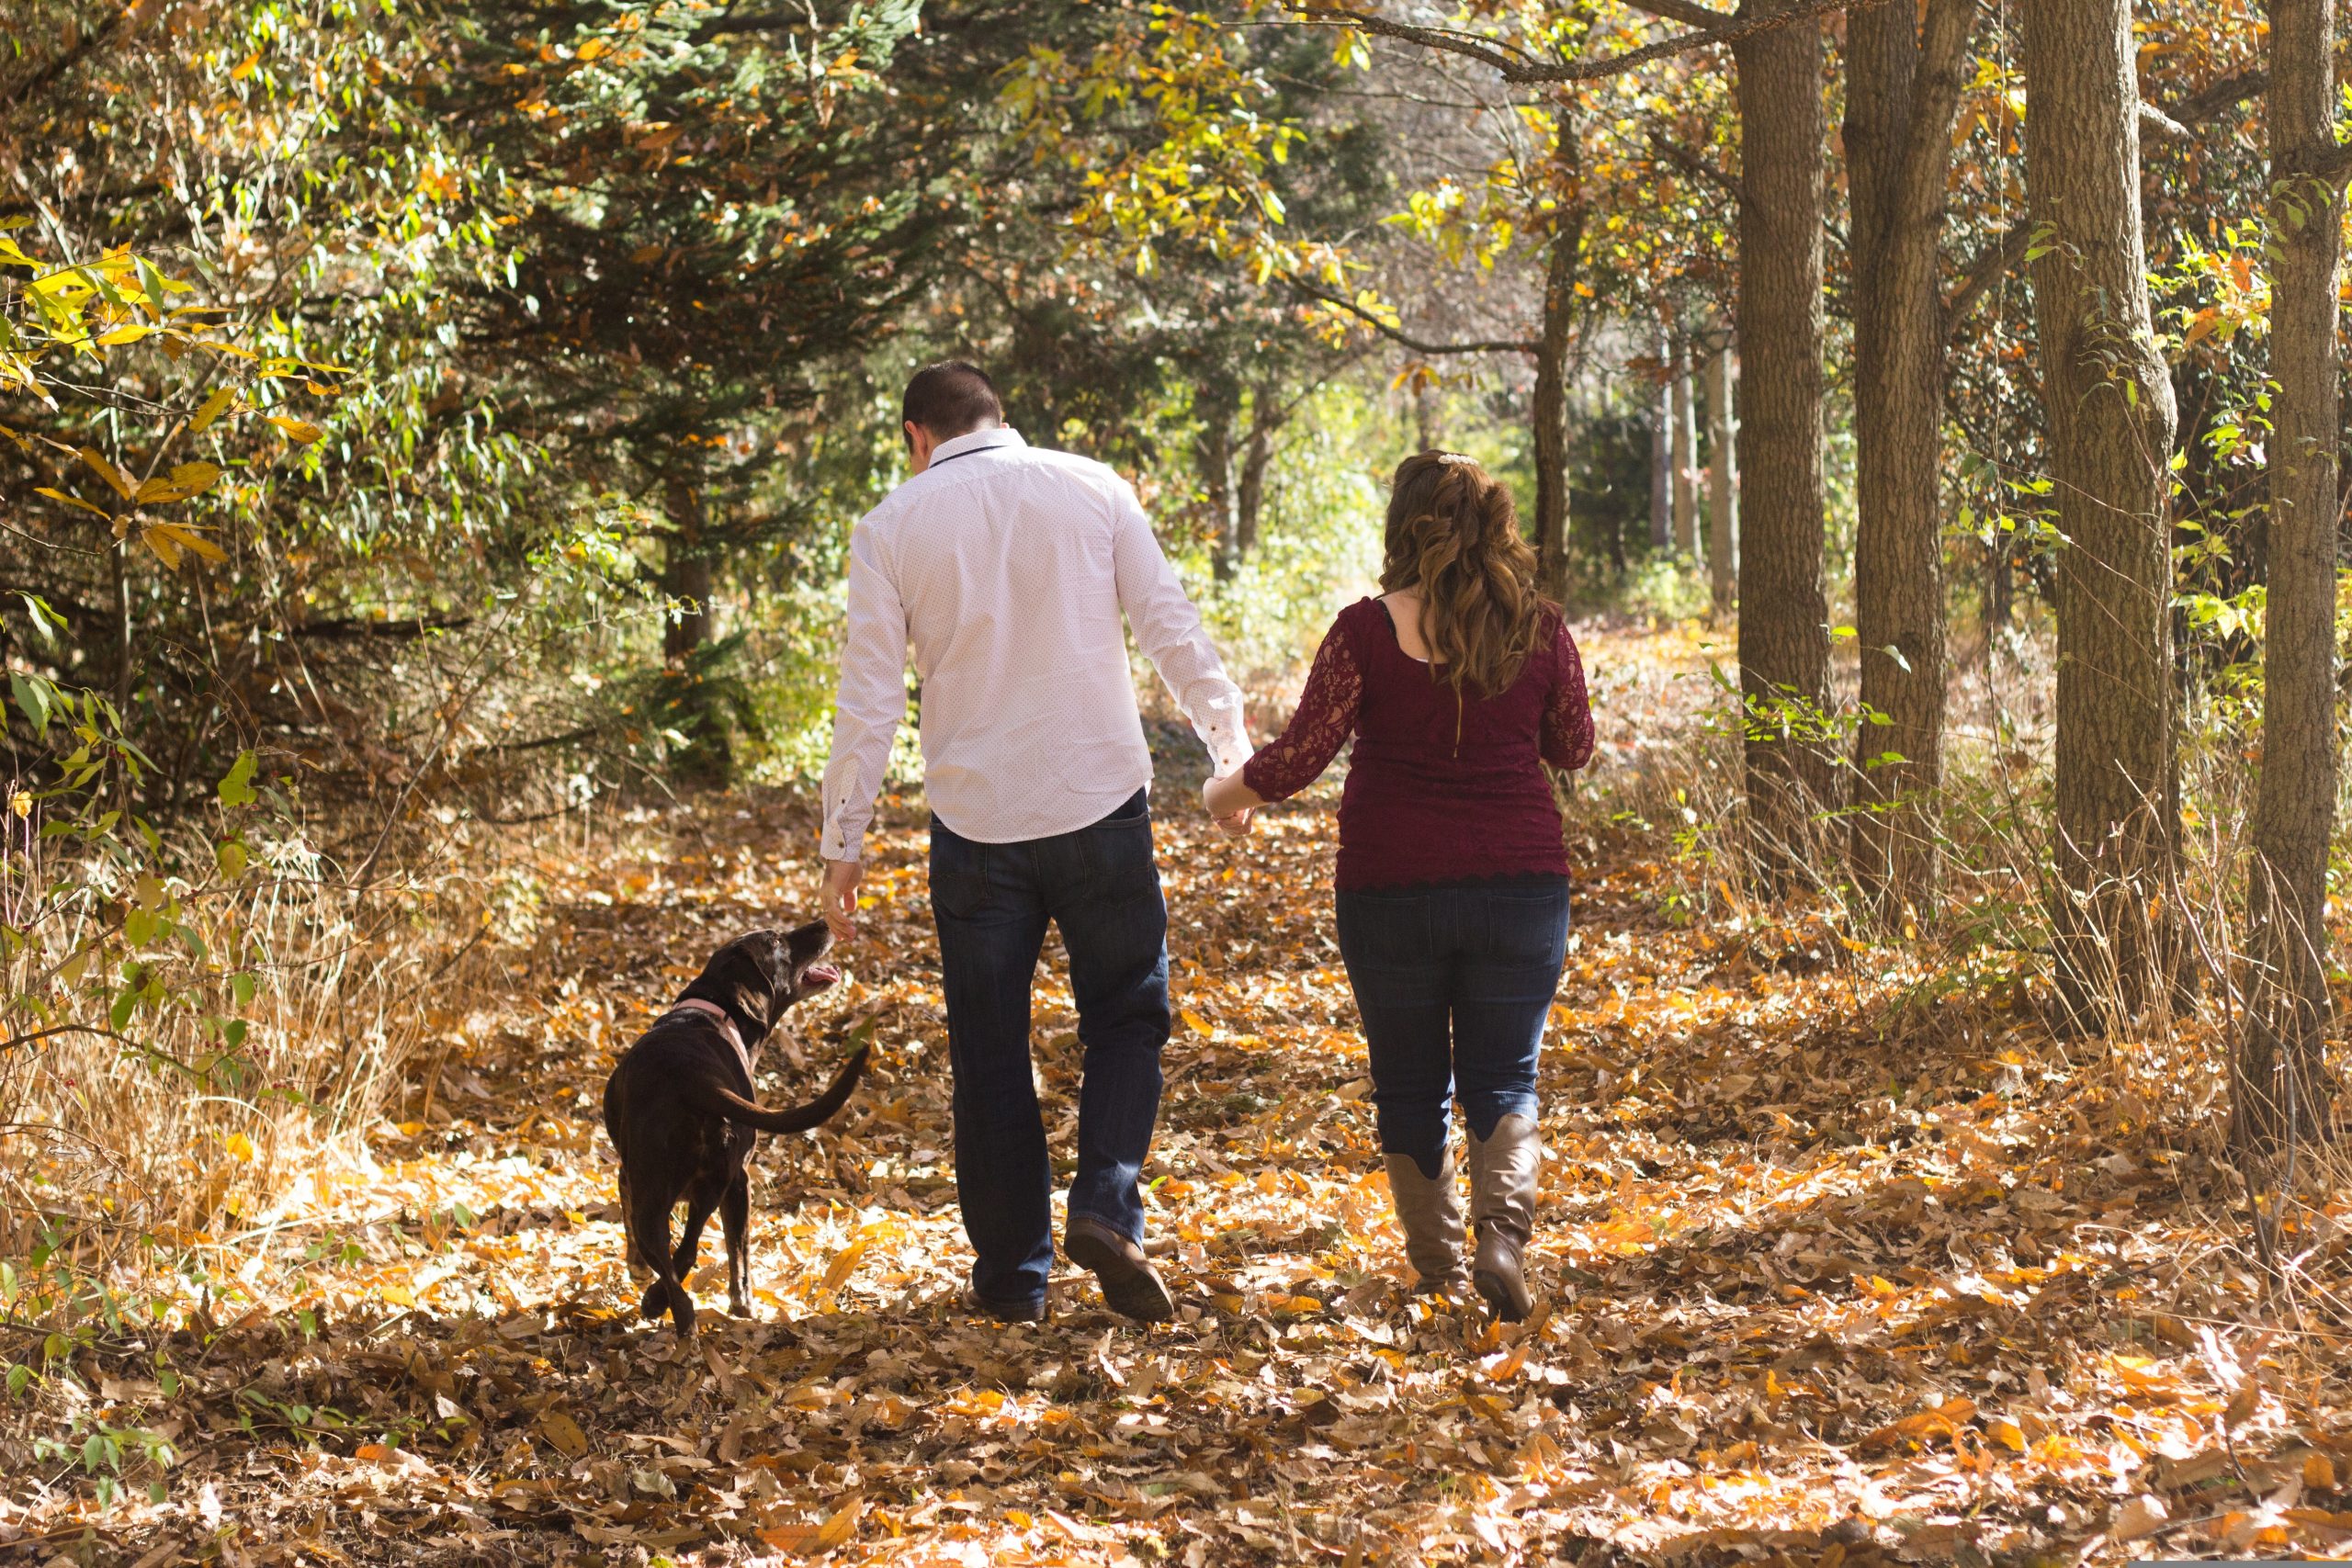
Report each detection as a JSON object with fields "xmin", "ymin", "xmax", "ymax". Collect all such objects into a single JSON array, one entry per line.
[{"xmin": 823, "ymin": 362, "xmax": 1249, "ymax": 1321}]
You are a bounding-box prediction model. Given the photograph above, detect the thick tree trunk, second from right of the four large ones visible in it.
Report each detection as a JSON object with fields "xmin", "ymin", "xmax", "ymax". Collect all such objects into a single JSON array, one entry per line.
[{"xmin": 2023, "ymin": 0, "xmax": 2178, "ymax": 1027}]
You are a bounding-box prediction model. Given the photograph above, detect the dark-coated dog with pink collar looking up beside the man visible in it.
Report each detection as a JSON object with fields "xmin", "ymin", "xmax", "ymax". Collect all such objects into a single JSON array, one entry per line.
[{"xmin": 605, "ymin": 921, "xmax": 865, "ymax": 1336}]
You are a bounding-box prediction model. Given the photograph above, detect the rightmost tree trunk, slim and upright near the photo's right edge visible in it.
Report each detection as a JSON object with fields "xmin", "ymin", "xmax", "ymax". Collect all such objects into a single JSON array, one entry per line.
[{"xmin": 2232, "ymin": 0, "xmax": 2345, "ymax": 1147}]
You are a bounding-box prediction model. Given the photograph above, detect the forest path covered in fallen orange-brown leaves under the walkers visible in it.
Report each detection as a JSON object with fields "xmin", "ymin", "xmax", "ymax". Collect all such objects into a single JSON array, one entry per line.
[{"xmin": 28, "ymin": 639, "xmax": 2352, "ymax": 1568}]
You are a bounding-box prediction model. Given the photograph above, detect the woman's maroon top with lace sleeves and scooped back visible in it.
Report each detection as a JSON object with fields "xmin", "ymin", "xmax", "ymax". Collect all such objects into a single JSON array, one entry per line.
[{"xmin": 1242, "ymin": 600, "xmax": 1592, "ymax": 888}]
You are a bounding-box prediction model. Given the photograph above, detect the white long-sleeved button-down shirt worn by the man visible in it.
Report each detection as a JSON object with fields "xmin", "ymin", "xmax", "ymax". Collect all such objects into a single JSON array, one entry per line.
[{"xmin": 823, "ymin": 428, "xmax": 1249, "ymax": 861}]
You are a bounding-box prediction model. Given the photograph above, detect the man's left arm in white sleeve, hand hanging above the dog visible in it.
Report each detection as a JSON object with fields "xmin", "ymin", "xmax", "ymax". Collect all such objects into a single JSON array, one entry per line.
[{"xmin": 823, "ymin": 522, "xmax": 906, "ymax": 938}]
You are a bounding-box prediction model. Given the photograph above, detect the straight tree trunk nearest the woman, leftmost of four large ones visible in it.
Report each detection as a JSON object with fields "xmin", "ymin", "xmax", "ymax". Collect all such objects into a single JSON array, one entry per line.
[{"xmin": 1731, "ymin": 0, "xmax": 1830, "ymax": 879}]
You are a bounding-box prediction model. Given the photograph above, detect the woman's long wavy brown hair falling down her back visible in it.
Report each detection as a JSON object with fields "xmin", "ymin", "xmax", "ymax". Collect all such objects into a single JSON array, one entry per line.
[{"xmin": 1381, "ymin": 451, "xmax": 1547, "ymax": 696}]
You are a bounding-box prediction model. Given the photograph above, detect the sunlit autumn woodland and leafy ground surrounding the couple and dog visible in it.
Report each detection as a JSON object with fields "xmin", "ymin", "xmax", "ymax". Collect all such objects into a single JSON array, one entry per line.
[{"xmin": 0, "ymin": 0, "xmax": 2352, "ymax": 1568}]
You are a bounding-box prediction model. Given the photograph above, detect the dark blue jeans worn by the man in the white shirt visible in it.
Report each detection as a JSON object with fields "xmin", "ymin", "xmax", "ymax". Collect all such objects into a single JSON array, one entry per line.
[{"xmin": 932, "ymin": 790, "xmax": 1169, "ymax": 1312}]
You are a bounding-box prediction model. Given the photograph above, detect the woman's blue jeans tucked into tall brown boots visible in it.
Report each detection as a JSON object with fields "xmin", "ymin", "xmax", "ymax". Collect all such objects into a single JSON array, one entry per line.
[{"xmin": 1339, "ymin": 877, "xmax": 1569, "ymax": 1178}]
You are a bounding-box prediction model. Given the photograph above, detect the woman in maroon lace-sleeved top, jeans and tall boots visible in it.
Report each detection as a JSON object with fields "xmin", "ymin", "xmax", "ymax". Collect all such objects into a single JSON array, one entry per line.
[{"xmin": 1206, "ymin": 451, "xmax": 1592, "ymax": 1321}]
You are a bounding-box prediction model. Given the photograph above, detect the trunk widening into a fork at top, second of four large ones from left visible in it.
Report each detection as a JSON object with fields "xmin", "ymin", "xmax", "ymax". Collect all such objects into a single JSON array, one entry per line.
[{"xmin": 1847, "ymin": 0, "xmax": 1966, "ymax": 908}]
